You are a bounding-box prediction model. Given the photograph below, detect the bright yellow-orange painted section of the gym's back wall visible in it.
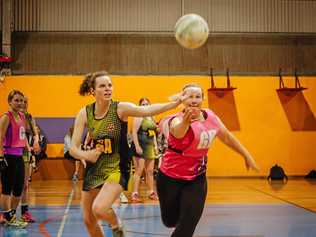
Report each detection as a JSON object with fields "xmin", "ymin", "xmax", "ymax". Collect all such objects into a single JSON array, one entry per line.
[{"xmin": 0, "ymin": 76, "xmax": 316, "ymax": 176}]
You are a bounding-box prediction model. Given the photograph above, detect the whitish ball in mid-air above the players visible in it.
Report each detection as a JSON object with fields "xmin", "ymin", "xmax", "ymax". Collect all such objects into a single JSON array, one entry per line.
[{"xmin": 175, "ymin": 14, "xmax": 209, "ymax": 49}]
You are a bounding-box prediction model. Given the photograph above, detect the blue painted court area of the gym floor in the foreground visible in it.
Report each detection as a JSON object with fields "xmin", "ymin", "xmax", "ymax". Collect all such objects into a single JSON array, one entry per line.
[{"xmin": 0, "ymin": 204, "xmax": 316, "ymax": 237}]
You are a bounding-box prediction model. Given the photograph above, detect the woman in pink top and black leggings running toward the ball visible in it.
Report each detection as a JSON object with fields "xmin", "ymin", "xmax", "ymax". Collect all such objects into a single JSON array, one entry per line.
[{"xmin": 157, "ymin": 84, "xmax": 258, "ymax": 237}]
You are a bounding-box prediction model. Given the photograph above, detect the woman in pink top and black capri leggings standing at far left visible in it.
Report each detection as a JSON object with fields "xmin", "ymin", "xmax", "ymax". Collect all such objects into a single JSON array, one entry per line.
[{"xmin": 0, "ymin": 90, "xmax": 27, "ymax": 228}]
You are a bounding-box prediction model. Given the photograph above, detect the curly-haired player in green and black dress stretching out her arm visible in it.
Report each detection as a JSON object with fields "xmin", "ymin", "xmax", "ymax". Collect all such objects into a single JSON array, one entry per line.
[{"xmin": 70, "ymin": 71, "xmax": 185, "ymax": 237}]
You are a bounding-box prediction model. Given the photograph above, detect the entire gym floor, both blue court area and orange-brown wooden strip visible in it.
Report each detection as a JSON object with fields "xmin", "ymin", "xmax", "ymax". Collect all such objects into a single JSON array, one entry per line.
[{"xmin": 0, "ymin": 178, "xmax": 316, "ymax": 237}]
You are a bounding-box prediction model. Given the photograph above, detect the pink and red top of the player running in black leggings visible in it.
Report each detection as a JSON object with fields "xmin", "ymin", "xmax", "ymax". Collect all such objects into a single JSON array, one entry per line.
[{"xmin": 160, "ymin": 109, "xmax": 219, "ymax": 180}]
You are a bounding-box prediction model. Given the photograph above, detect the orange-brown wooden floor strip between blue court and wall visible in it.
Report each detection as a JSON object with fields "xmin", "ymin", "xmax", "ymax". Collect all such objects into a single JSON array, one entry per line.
[{"xmin": 30, "ymin": 178, "xmax": 316, "ymax": 212}]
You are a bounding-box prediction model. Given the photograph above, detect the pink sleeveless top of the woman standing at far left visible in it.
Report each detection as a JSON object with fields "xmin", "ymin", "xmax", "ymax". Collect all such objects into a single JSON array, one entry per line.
[{"xmin": 3, "ymin": 111, "xmax": 26, "ymax": 156}]
